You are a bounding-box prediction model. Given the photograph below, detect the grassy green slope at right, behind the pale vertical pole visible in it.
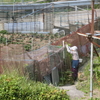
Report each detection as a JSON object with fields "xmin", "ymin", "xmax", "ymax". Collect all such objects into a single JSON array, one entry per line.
[{"xmin": 76, "ymin": 57, "xmax": 100, "ymax": 100}]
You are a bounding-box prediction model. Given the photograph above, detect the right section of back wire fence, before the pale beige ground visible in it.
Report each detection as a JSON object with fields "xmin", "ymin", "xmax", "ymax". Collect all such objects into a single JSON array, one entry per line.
[{"xmin": 55, "ymin": 2, "xmax": 91, "ymax": 28}]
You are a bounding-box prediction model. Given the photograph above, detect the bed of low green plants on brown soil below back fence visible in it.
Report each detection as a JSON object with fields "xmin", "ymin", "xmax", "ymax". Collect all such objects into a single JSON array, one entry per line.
[{"xmin": 0, "ymin": 30, "xmax": 63, "ymax": 51}]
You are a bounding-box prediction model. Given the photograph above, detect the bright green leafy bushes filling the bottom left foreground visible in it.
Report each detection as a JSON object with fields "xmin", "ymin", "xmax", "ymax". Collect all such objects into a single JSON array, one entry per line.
[{"xmin": 0, "ymin": 72, "xmax": 69, "ymax": 100}]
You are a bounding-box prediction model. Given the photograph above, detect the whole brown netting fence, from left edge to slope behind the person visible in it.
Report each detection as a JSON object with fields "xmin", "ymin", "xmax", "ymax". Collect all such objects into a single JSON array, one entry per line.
[{"xmin": 0, "ymin": 23, "xmax": 99, "ymax": 84}]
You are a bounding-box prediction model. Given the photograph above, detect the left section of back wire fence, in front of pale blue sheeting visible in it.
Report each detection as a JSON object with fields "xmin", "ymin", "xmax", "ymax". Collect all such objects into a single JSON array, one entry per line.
[{"xmin": 0, "ymin": 4, "xmax": 53, "ymax": 33}]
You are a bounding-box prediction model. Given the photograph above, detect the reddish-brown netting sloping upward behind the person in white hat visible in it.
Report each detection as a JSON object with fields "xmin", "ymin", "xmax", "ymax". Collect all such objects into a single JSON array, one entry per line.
[{"xmin": 52, "ymin": 23, "xmax": 91, "ymax": 57}]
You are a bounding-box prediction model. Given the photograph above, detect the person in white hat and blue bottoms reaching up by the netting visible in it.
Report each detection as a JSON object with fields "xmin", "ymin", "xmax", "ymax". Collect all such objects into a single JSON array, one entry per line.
[{"xmin": 66, "ymin": 45, "xmax": 79, "ymax": 80}]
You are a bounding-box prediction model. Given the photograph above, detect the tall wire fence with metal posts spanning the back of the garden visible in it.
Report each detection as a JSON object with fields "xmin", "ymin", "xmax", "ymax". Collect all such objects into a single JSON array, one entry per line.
[{"xmin": 0, "ymin": 1, "xmax": 99, "ymax": 33}]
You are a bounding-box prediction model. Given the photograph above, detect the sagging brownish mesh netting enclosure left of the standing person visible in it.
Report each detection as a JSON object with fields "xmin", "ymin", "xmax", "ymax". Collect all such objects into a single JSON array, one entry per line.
[{"xmin": 0, "ymin": 45, "xmax": 71, "ymax": 85}]
